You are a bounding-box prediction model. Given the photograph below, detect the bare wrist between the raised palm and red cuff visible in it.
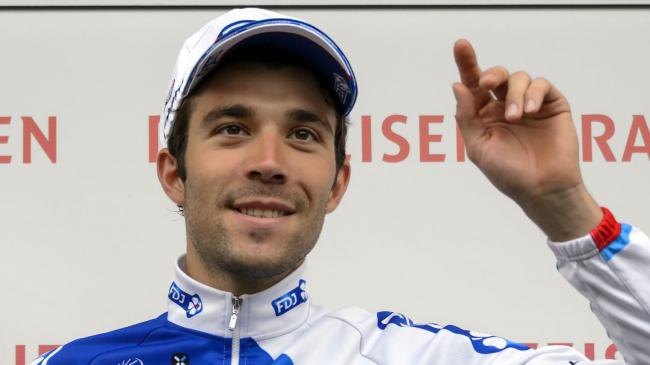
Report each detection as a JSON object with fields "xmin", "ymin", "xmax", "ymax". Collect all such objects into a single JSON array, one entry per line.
[{"xmin": 521, "ymin": 184, "xmax": 603, "ymax": 242}]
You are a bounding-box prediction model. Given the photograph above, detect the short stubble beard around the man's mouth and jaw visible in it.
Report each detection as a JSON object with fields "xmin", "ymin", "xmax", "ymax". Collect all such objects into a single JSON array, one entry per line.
[{"xmin": 183, "ymin": 179, "xmax": 326, "ymax": 279}]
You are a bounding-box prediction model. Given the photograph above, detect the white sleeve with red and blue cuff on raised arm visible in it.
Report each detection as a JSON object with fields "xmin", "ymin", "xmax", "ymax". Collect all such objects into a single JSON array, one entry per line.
[{"xmin": 548, "ymin": 208, "xmax": 650, "ymax": 365}]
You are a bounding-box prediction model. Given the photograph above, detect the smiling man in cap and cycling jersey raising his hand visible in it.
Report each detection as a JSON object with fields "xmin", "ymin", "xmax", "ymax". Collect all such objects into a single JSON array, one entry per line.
[{"xmin": 34, "ymin": 9, "xmax": 650, "ymax": 365}]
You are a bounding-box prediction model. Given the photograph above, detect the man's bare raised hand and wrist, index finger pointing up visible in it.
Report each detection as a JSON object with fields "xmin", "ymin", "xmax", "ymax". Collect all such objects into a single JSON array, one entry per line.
[{"xmin": 453, "ymin": 40, "xmax": 602, "ymax": 240}]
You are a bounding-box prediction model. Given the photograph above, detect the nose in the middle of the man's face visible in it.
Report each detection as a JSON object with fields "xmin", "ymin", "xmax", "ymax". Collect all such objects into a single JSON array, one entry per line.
[{"xmin": 246, "ymin": 131, "xmax": 287, "ymax": 184}]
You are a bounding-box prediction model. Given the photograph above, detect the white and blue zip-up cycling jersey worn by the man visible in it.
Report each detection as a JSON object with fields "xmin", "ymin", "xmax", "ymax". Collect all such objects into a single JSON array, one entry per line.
[{"xmin": 32, "ymin": 209, "xmax": 650, "ymax": 365}]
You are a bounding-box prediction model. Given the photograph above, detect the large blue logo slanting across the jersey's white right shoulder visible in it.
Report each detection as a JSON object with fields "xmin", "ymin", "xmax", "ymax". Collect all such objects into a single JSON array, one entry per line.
[{"xmin": 377, "ymin": 312, "xmax": 529, "ymax": 354}]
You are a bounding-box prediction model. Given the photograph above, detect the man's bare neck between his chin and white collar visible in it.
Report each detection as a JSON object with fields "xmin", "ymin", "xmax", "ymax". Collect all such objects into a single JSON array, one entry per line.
[{"xmin": 185, "ymin": 242, "xmax": 294, "ymax": 296}]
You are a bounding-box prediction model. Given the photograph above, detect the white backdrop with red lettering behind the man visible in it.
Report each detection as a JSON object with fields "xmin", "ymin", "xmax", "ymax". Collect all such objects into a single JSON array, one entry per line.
[{"xmin": 0, "ymin": 8, "xmax": 650, "ymax": 365}]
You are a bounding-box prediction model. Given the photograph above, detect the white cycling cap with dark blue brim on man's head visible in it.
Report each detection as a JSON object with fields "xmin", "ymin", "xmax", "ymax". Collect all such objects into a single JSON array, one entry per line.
[{"xmin": 158, "ymin": 8, "xmax": 357, "ymax": 148}]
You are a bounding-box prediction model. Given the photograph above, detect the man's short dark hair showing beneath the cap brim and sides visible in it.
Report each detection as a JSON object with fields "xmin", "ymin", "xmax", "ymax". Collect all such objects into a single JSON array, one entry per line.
[{"xmin": 167, "ymin": 45, "xmax": 349, "ymax": 181}]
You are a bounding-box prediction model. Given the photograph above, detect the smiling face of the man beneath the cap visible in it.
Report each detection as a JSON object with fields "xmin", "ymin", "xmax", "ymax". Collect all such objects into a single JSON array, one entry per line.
[{"xmin": 172, "ymin": 63, "xmax": 349, "ymax": 278}]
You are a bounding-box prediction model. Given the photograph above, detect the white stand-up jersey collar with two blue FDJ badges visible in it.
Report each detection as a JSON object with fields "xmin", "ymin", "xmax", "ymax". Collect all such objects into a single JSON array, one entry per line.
[{"xmin": 167, "ymin": 255, "xmax": 310, "ymax": 340}]
